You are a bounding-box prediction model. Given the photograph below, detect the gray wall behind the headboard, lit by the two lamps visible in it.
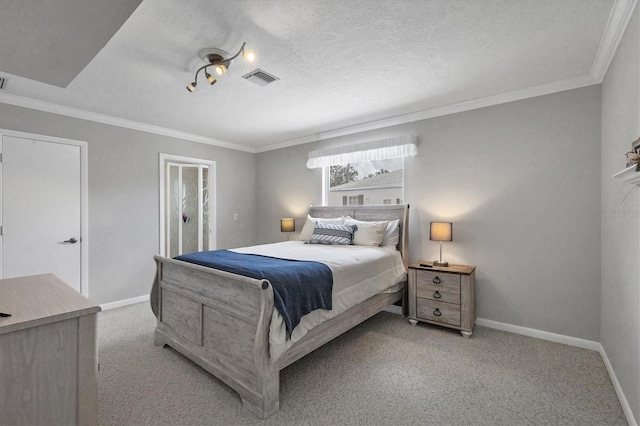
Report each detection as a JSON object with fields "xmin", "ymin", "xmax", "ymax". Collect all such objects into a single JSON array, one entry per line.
[{"xmin": 256, "ymin": 86, "xmax": 600, "ymax": 341}]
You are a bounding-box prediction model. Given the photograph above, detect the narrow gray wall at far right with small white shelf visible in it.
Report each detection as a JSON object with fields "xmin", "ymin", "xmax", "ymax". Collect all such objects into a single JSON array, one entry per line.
[{"xmin": 600, "ymin": 8, "xmax": 640, "ymax": 420}]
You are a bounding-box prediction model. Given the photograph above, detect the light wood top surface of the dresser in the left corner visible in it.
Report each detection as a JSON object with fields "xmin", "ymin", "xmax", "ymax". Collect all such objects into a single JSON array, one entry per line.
[{"xmin": 0, "ymin": 274, "xmax": 100, "ymax": 334}]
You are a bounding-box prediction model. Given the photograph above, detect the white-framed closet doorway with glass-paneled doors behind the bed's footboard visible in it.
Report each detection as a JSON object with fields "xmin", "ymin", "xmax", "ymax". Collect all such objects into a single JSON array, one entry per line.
[{"xmin": 160, "ymin": 154, "xmax": 216, "ymax": 257}]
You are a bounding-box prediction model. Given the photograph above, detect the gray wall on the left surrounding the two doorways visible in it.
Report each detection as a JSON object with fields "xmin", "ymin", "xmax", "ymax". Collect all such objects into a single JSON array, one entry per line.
[{"xmin": 0, "ymin": 103, "xmax": 256, "ymax": 304}]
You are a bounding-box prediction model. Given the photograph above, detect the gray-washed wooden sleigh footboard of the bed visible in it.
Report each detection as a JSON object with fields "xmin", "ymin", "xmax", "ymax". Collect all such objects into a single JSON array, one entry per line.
[{"xmin": 151, "ymin": 256, "xmax": 280, "ymax": 418}]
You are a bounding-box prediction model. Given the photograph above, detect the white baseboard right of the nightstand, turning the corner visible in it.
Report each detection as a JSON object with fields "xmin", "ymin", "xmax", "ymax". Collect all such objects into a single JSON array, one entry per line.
[{"xmin": 476, "ymin": 318, "xmax": 638, "ymax": 426}]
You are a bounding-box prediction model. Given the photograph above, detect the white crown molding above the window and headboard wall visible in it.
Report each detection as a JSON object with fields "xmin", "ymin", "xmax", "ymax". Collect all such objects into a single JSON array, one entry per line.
[{"xmin": 256, "ymin": 74, "xmax": 599, "ymax": 153}]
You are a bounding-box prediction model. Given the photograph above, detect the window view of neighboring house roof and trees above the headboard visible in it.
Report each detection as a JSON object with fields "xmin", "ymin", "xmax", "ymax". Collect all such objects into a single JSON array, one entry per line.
[{"xmin": 327, "ymin": 158, "xmax": 404, "ymax": 206}]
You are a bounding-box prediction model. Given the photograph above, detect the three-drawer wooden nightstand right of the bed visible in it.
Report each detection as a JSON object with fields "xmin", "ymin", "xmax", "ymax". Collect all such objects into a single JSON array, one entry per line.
[{"xmin": 408, "ymin": 262, "xmax": 476, "ymax": 337}]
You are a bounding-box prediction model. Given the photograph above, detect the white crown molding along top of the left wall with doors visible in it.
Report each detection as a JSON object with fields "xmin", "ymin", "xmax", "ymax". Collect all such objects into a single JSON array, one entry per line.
[{"xmin": 0, "ymin": 93, "xmax": 256, "ymax": 154}]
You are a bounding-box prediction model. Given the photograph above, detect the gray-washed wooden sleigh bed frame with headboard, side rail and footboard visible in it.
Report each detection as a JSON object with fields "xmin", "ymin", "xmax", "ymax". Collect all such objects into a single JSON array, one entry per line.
[{"xmin": 151, "ymin": 204, "xmax": 409, "ymax": 418}]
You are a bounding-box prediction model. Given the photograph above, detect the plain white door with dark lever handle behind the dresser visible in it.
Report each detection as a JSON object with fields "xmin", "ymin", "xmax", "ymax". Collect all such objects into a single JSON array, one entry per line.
[{"xmin": 2, "ymin": 136, "xmax": 83, "ymax": 292}]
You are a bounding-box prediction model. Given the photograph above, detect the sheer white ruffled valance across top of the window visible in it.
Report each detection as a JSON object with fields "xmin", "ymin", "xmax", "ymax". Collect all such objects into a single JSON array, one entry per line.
[{"xmin": 307, "ymin": 135, "xmax": 418, "ymax": 169}]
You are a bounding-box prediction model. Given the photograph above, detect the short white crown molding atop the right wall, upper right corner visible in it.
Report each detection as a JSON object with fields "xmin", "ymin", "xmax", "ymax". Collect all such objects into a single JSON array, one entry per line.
[{"xmin": 591, "ymin": 0, "xmax": 638, "ymax": 83}]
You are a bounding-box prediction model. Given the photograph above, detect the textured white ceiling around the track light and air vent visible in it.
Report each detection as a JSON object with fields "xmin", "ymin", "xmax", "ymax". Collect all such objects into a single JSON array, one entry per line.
[{"xmin": 0, "ymin": 0, "xmax": 636, "ymax": 152}]
